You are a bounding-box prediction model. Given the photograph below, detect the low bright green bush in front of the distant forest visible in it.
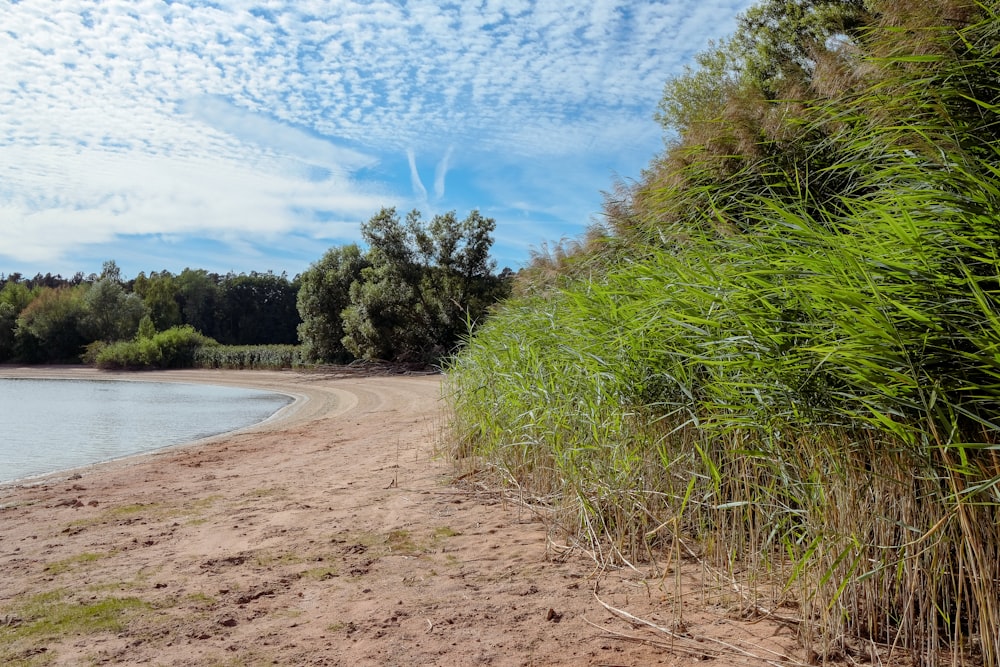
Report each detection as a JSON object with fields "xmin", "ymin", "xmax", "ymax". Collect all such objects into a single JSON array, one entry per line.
[{"xmin": 95, "ymin": 325, "xmax": 218, "ymax": 369}]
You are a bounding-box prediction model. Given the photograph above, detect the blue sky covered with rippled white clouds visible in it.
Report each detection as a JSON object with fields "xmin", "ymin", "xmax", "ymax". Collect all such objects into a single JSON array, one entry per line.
[{"xmin": 0, "ymin": 0, "xmax": 752, "ymax": 277}]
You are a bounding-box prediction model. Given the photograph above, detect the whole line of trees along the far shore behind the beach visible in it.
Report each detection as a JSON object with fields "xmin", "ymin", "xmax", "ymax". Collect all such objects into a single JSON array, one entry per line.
[{"xmin": 0, "ymin": 209, "xmax": 510, "ymax": 363}]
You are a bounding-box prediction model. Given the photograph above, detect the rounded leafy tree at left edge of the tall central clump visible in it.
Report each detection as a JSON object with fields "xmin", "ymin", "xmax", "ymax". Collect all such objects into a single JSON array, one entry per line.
[{"xmin": 297, "ymin": 244, "xmax": 369, "ymax": 362}]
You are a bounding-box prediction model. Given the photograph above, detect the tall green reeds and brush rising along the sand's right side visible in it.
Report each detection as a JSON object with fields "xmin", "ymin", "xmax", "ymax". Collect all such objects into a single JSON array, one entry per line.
[{"xmin": 448, "ymin": 0, "xmax": 1000, "ymax": 666}]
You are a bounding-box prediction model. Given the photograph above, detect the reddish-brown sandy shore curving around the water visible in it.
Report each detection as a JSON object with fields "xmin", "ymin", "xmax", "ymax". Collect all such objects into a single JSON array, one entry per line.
[{"xmin": 0, "ymin": 368, "xmax": 809, "ymax": 666}]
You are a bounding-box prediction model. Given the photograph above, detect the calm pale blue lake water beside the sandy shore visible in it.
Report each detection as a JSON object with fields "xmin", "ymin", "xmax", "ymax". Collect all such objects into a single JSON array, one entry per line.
[{"xmin": 0, "ymin": 378, "xmax": 292, "ymax": 482}]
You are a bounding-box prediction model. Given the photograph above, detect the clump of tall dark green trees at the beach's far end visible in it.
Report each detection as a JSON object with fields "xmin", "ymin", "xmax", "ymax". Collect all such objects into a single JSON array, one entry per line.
[{"xmin": 299, "ymin": 209, "xmax": 508, "ymax": 362}]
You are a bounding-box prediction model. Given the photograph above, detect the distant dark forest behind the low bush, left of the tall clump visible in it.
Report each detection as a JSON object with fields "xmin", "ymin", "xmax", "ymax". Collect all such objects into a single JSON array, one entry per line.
[{"xmin": 0, "ymin": 260, "xmax": 302, "ymax": 363}]
